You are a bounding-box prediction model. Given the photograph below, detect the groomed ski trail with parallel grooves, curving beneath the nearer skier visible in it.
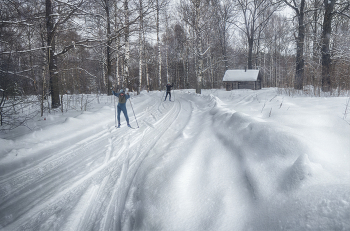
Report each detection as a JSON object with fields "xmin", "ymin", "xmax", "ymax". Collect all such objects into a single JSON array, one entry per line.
[{"xmin": 0, "ymin": 91, "xmax": 190, "ymax": 230}]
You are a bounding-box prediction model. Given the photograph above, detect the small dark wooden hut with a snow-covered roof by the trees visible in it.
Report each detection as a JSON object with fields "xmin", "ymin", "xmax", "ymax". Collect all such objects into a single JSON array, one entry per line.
[{"xmin": 222, "ymin": 70, "xmax": 261, "ymax": 91}]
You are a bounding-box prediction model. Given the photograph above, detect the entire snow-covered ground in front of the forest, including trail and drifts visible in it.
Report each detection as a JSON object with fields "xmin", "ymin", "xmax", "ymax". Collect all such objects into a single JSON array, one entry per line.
[{"xmin": 0, "ymin": 89, "xmax": 350, "ymax": 231}]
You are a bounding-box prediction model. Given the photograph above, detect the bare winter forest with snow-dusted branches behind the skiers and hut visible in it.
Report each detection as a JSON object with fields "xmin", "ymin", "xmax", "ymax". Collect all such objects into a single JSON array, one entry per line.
[{"xmin": 0, "ymin": 0, "xmax": 350, "ymax": 130}]
